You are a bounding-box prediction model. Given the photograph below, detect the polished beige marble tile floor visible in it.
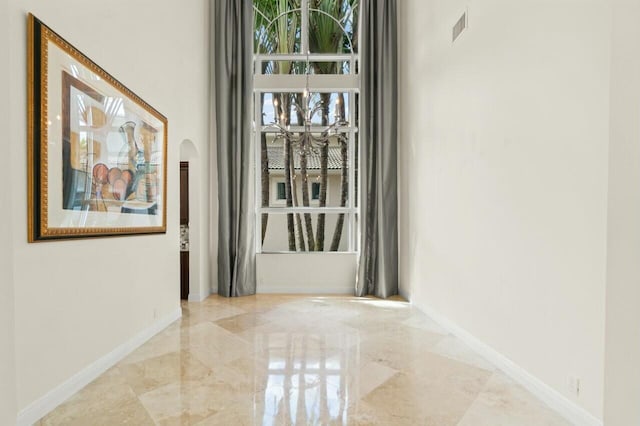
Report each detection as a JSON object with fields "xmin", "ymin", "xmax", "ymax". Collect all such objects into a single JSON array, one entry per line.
[{"xmin": 37, "ymin": 295, "xmax": 569, "ymax": 426}]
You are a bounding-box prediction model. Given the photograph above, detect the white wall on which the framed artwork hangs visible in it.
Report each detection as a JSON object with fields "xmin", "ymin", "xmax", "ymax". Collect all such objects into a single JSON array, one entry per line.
[{"xmin": 3, "ymin": 0, "xmax": 209, "ymax": 410}]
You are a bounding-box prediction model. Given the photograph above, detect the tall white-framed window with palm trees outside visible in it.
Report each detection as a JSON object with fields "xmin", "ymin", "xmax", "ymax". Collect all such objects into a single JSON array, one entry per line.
[{"xmin": 253, "ymin": 0, "xmax": 360, "ymax": 252}]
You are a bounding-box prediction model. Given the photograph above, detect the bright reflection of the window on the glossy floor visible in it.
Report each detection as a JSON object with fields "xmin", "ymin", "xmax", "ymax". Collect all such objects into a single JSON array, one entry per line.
[{"xmin": 256, "ymin": 333, "xmax": 359, "ymax": 425}]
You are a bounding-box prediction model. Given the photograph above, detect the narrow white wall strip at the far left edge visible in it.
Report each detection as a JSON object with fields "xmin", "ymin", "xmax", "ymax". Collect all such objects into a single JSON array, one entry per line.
[{"xmin": 0, "ymin": 0, "xmax": 17, "ymax": 425}]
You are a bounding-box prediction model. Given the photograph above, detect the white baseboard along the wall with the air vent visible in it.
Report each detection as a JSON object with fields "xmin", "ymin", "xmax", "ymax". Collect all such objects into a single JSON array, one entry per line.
[{"xmin": 414, "ymin": 305, "xmax": 602, "ymax": 426}]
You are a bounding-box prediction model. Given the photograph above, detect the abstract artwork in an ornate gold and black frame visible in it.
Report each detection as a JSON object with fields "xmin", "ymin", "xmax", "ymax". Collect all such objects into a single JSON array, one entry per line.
[{"xmin": 28, "ymin": 14, "xmax": 167, "ymax": 242}]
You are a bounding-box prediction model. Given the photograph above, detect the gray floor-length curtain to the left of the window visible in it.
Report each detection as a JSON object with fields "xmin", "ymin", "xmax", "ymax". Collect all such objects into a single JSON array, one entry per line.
[{"xmin": 212, "ymin": 0, "xmax": 256, "ymax": 297}]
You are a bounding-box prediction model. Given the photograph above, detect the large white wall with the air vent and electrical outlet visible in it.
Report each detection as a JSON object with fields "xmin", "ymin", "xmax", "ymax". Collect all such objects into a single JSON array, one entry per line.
[{"xmin": 400, "ymin": 0, "xmax": 611, "ymax": 418}]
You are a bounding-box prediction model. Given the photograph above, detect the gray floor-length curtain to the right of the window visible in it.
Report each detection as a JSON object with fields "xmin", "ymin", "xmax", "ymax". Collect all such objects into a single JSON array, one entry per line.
[{"xmin": 356, "ymin": 0, "xmax": 398, "ymax": 298}]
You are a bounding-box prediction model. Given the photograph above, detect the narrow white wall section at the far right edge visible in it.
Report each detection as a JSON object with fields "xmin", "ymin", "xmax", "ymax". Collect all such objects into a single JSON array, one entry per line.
[{"xmin": 604, "ymin": 0, "xmax": 640, "ymax": 426}]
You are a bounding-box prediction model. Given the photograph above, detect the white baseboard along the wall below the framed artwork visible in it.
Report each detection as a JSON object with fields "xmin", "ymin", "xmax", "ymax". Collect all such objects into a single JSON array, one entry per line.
[{"xmin": 17, "ymin": 308, "xmax": 182, "ymax": 426}]
